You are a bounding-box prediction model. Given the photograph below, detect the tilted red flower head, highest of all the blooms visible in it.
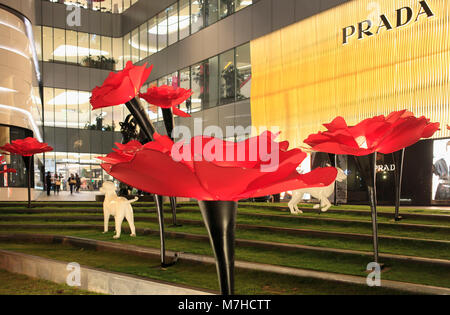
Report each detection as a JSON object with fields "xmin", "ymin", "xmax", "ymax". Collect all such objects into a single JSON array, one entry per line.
[{"xmin": 91, "ymin": 61, "xmax": 153, "ymax": 109}]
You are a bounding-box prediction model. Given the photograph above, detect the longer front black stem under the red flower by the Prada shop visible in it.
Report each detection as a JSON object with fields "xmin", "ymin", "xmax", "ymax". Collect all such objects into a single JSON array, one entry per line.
[{"xmin": 355, "ymin": 152, "xmax": 378, "ymax": 263}]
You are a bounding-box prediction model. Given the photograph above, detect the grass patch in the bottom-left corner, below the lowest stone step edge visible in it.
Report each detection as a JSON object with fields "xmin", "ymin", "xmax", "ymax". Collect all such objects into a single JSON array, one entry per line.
[{"xmin": 0, "ymin": 269, "xmax": 95, "ymax": 295}]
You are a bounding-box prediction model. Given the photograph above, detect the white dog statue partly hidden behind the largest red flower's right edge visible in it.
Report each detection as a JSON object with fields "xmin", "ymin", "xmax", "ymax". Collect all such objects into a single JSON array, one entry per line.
[{"xmin": 288, "ymin": 168, "xmax": 347, "ymax": 214}]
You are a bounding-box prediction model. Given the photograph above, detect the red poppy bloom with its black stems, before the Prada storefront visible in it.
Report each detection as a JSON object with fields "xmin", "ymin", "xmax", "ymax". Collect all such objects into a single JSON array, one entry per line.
[{"xmin": 304, "ymin": 110, "xmax": 439, "ymax": 262}]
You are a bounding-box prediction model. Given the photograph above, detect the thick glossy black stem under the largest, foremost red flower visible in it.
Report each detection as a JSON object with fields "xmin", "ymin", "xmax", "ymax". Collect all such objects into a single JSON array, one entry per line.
[{"xmin": 198, "ymin": 200, "xmax": 238, "ymax": 295}]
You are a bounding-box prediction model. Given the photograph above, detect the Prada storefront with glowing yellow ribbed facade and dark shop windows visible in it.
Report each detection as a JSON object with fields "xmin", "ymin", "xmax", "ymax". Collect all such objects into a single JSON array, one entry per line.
[{"xmin": 251, "ymin": 0, "xmax": 450, "ymax": 204}]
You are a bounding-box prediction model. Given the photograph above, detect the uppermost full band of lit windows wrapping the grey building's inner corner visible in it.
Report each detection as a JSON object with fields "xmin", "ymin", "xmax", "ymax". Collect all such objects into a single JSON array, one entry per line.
[{"xmin": 35, "ymin": 0, "xmax": 254, "ymax": 70}]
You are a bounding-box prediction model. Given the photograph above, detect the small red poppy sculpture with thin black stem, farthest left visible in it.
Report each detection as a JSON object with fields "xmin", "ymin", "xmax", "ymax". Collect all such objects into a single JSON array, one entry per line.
[{"xmin": 0, "ymin": 137, "xmax": 53, "ymax": 208}]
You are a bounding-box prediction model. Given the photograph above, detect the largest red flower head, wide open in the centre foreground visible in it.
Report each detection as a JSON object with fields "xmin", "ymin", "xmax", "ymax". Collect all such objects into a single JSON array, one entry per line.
[{"xmin": 99, "ymin": 132, "xmax": 337, "ymax": 201}]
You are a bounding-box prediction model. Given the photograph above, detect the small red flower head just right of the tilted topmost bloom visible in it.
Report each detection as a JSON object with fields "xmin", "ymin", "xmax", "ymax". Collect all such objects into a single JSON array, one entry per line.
[{"xmin": 139, "ymin": 85, "xmax": 192, "ymax": 117}]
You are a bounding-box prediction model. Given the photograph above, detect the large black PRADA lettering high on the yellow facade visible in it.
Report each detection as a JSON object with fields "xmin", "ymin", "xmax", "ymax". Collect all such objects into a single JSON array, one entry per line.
[{"xmin": 342, "ymin": 0, "xmax": 434, "ymax": 45}]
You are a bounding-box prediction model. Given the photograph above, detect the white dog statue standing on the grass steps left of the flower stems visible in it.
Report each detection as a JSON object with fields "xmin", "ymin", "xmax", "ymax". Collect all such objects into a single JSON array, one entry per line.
[{"xmin": 100, "ymin": 181, "xmax": 139, "ymax": 239}]
